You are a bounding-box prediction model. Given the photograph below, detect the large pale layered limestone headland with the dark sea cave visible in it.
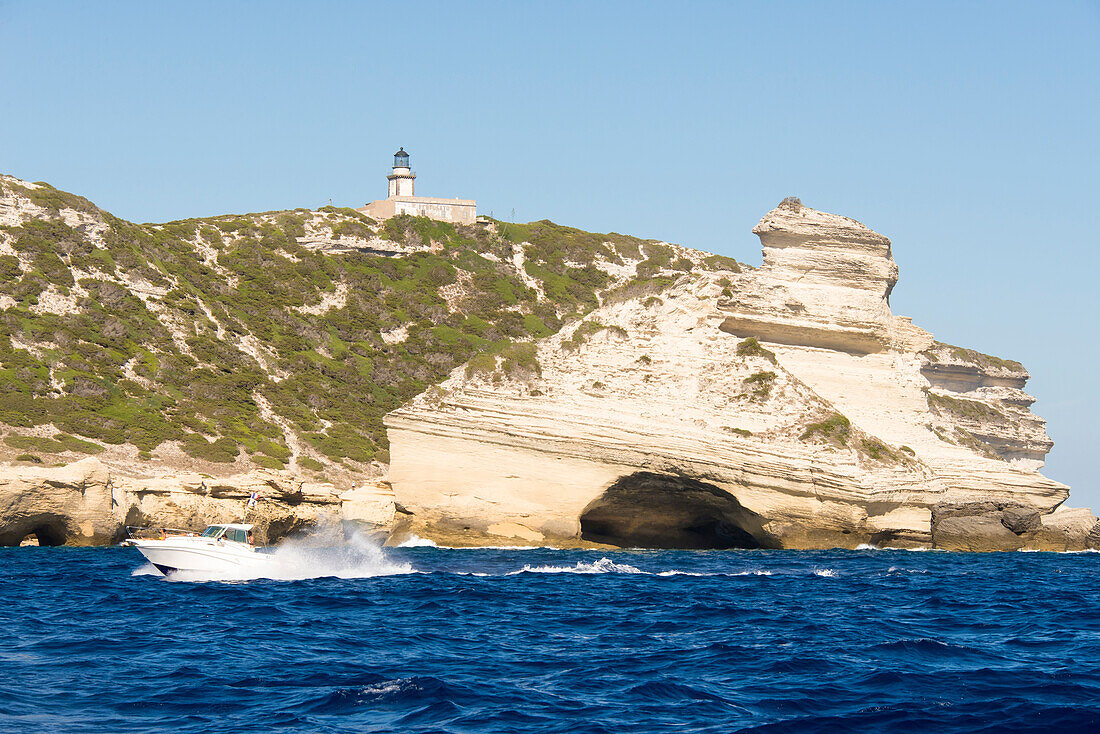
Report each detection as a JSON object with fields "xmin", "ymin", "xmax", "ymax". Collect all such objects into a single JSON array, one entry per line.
[{"xmin": 386, "ymin": 200, "xmax": 1082, "ymax": 549}]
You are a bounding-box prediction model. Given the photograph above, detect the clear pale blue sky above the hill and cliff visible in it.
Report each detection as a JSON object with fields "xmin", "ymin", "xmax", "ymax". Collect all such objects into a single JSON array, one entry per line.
[{"xmin": 0, "ymin": 0, "xmax": 1100, "ymax": 510}]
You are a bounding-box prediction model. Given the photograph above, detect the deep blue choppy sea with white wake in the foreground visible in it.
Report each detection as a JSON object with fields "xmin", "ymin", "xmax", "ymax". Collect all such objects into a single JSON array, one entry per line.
[{"xmin": 0, "ymin": 541, "xmax": 1100, "ymax": 734}]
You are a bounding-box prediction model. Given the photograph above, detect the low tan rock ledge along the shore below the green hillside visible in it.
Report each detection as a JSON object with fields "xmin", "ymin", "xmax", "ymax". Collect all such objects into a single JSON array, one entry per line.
[{"xmin": 0, "ymin": 458, "xmax": 394, "ymax": 546}]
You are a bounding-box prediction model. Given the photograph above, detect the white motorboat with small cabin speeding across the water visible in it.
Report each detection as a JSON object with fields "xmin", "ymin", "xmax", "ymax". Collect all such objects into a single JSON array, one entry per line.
[{"xmin": 122, "ymin": 524, "xmax": 275, "ymax": 576}]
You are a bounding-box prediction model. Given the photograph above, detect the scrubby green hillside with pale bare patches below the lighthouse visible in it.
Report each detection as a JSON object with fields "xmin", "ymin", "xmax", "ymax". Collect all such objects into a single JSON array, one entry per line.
[{"xmin": 0, "ymin": 177, "xmax": 730, "ymax": 484}]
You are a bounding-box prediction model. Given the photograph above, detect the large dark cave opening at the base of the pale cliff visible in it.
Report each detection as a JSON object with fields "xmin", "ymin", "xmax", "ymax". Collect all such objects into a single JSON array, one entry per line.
[{"xmin": 581, "ymin": 471, "xmax": 779, "ymax": 549}]
